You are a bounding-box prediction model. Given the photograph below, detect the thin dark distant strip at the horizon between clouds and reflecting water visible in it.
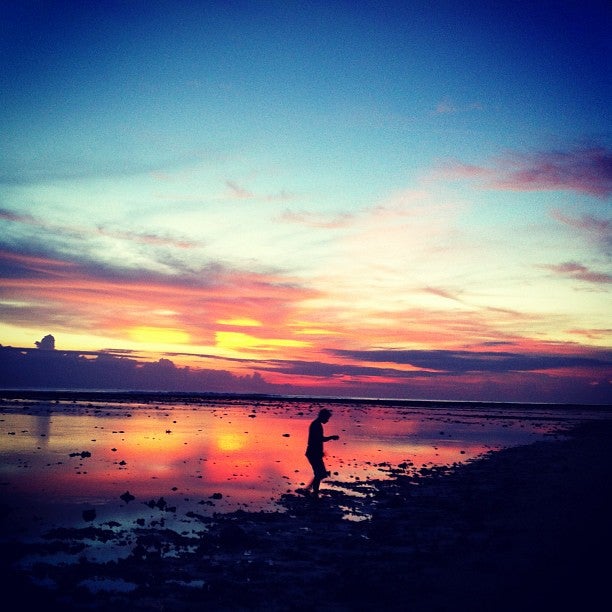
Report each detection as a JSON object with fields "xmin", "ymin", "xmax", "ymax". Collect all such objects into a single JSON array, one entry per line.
[{"xmin": 0, "ymin": 388, "xmax": 612, "ymax": 411}]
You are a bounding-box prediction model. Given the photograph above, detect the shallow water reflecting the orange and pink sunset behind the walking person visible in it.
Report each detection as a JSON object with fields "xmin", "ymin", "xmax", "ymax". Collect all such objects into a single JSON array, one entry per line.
[{"xmin": 0, "ymin": 400, "xmax": 604, "ymax": 526}]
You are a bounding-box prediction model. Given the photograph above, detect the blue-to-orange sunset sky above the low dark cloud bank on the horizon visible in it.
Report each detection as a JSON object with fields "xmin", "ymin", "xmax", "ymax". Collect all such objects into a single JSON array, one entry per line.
[{"xmin": 0, "ymin": 0, "xmax": 612, "ymax": 402}]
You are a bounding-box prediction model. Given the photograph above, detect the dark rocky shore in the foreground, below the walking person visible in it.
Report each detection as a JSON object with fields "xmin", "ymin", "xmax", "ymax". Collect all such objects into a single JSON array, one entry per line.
[{"xmin": 0, "ymin": 421, "xmax": 612, "ymax": 612}]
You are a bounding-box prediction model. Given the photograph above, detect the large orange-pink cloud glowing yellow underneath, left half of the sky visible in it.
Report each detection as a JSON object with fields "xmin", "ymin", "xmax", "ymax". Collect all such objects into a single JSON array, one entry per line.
[{"xmin": 0, "ymin": 253, "xmax": 322, "ymax": 351}]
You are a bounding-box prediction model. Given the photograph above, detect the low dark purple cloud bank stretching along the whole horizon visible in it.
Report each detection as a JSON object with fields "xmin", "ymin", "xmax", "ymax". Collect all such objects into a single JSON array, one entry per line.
[{"xmin": 0, "ymin": 336, "xmax": 612, "ymax": 405}]
